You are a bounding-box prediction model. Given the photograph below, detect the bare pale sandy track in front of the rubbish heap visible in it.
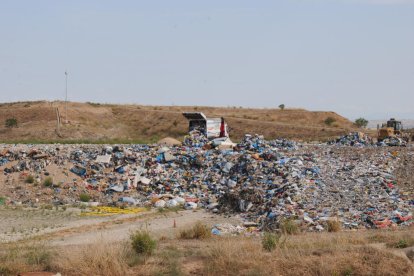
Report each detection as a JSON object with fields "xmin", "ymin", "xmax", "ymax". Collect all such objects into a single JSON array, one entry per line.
[{"xmin": 0, "ymin": 208, "xmax": 241, "ymax": 246}]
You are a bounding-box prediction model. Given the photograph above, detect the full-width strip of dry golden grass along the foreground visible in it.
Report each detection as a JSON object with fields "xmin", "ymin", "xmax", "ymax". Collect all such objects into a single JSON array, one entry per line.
[{"xmin": 0, "ymin": 229, "xmax": 414, "ymax": 275}]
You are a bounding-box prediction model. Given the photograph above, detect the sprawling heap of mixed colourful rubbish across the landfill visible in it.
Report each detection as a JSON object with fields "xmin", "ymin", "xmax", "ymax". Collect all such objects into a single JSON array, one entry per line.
[{"xmin": 0, "ymin": 131, "xmax": 414, "ymax": 233}]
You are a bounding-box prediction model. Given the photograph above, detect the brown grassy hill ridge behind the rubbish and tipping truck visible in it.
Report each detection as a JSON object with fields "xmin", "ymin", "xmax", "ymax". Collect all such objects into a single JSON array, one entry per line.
[{"xmin": 0, "ymin": 101, "xmax": 354, "ymax": 143}]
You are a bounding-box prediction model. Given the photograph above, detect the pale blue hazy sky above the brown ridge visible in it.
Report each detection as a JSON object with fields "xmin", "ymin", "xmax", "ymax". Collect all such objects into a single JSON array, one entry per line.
[{"xmin": 0, "ymin": 0, "xmax": 414, "ymax": 119}]
